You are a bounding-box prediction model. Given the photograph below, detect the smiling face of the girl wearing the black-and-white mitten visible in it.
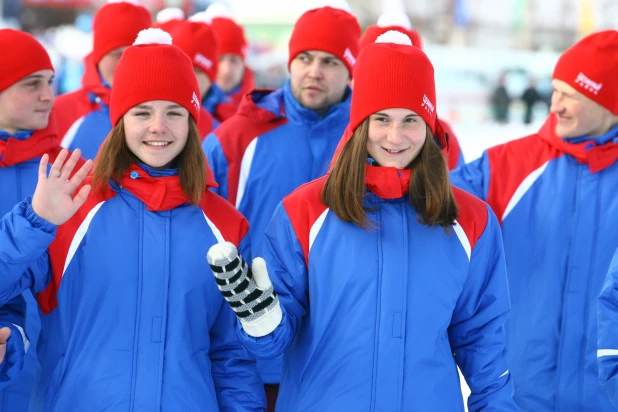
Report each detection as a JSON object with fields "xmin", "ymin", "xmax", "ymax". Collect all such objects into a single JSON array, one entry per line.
[{"xmin": 367, "ymin": 109, "xmax": 427, "ymax": 169}]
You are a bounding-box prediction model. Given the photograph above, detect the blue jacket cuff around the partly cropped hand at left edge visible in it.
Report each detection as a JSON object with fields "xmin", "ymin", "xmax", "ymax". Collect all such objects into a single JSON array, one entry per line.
[{"xmin": 0, "ymin": 294, "xmax": 30, "ymax": 389}]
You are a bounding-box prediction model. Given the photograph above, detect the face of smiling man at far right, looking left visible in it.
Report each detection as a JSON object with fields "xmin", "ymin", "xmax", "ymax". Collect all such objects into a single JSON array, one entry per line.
[{"xmin": 551, "ymin": 79, "xmax": 618, "ymax": 139}]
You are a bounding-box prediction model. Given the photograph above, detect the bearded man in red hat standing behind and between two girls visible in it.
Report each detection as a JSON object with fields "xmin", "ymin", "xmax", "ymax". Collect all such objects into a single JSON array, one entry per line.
[{"xmin": 204, "ymin": 7, "xmax": 361, "ymax": 408}]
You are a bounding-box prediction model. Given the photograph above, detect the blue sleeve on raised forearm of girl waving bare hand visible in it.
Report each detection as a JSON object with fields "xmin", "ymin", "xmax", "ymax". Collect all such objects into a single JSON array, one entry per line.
[{"xmin": 0, "ymin": 198, "xmax": 56, "ymax": 305}]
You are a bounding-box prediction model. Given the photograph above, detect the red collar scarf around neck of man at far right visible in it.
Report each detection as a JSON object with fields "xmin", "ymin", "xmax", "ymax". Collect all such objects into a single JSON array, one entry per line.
[{"xmin": 538, "ymin": 115, "xmax": 618, "ymax": 173}]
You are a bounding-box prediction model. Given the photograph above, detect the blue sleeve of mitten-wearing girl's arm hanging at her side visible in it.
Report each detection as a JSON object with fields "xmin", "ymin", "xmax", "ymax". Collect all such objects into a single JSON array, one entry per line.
[{"xmin": 448, "ymin": 207, "xmax": 517, "ymax": 412}]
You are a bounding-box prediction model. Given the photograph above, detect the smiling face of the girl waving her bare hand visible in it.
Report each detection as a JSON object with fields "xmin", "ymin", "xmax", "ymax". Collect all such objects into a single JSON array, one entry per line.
[{"xmin": 123, "ymin": 100, "xmax": 189, "ymax": 169}]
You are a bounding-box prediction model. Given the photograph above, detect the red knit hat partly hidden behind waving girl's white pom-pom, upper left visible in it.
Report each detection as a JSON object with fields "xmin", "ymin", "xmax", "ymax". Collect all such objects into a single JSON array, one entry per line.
[{"xmin": 92, "ymin": 0, "xmax": 152, "ymax": 64}]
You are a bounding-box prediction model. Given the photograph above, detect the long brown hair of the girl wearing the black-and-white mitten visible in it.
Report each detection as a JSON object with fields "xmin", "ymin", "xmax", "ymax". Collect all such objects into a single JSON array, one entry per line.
[{"xmin": 322, "ymin": 118, "xmax": 459, "ymax": 229}]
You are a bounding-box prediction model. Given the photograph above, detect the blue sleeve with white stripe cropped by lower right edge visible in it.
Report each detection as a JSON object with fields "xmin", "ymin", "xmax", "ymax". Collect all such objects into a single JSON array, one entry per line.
[{"xmin": 597, "ymin": 246, "xmax": 618, "ymax": 408}]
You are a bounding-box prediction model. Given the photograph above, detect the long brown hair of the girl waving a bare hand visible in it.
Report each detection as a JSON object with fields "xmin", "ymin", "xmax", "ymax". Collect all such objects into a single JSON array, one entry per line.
[{"xmin": 92, "ymin": 116, "xmax": 207, "ymax": 205}]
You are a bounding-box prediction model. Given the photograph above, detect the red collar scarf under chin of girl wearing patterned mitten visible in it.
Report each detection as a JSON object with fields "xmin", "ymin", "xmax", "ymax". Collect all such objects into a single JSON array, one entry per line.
[{"xmin": 365, "ymin": 165, "xmax": 412, "ymax": 199}]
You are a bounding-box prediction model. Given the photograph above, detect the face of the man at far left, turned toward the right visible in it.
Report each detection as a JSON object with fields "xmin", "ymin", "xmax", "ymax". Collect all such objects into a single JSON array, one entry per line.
[{"xmin": 0, "ymin": 70, "xmax": 55, "ymax": 133}]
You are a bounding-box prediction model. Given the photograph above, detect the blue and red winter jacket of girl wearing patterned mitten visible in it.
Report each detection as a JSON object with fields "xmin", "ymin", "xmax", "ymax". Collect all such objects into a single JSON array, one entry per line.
[{"xmin": 238, "ymin": 168, "xmax": 517, "ymax": 412}]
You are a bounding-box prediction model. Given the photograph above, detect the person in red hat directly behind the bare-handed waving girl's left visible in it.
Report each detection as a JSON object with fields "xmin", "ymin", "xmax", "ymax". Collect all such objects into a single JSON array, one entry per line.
[{"xmin": 54, "ymin": 0, "xmax": 152, "ymax": 159}]
